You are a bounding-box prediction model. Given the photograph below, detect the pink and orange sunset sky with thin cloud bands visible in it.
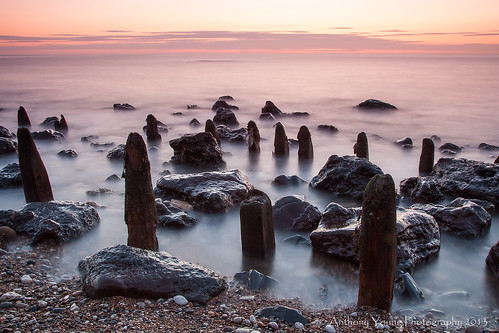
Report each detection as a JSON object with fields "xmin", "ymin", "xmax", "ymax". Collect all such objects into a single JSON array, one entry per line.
[{"xmin": 0, "ymin": 0, "xmax": 499, "ymax": 55}]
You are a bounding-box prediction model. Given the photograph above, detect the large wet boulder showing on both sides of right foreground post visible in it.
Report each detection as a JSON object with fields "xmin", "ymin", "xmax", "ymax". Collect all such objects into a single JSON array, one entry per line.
[{"xmin": 310, "ymin": 203, "xmax": 440, "ymax": 273}]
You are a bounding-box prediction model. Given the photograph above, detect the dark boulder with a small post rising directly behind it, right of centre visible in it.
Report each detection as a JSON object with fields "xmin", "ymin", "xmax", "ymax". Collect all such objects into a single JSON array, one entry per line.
[{"xmin": 310, "ymin": 155, "xmax": 383, "ymax": 199}]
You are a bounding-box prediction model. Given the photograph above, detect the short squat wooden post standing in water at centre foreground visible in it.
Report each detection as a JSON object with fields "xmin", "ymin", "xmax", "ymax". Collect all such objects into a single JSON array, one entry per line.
[{"xmin": 239, "ymin": 189, "xmax": 275, "ymax": 258}]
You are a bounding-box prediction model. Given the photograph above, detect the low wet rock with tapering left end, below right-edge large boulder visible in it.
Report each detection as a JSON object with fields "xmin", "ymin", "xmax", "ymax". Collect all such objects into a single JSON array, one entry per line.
[{"xmin": 411, "ymin": 198, "xmax": 492, "ymax": 238}]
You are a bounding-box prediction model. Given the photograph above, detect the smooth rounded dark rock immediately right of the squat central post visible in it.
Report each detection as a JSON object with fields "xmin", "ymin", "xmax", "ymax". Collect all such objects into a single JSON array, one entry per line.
[{"xmin": 273, "ymin": 196, "xmax": 322, "ymax": 231}]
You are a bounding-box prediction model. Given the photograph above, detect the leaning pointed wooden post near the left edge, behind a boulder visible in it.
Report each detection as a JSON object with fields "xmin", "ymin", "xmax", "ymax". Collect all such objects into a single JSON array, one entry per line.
[{"xmin": 17, "ymin": 127, "xmax": 54, "ymax": 202}]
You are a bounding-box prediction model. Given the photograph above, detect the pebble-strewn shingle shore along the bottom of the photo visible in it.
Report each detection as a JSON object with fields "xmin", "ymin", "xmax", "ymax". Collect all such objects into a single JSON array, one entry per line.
[{"xmin": 0, "ymin": 241, "xmax": 498, "ymax": 332}]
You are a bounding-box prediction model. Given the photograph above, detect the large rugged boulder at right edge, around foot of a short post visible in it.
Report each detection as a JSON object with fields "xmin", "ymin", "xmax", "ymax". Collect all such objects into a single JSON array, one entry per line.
[{"xmin": 400, "ymin": 158, "xmax": 499, "ymax": 206}]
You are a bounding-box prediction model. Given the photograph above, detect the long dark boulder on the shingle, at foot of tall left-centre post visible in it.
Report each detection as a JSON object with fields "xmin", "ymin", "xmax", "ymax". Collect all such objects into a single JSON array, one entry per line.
[{"xmin": 78, "ymin": 245, "xmax": 226, "ymax": 304}]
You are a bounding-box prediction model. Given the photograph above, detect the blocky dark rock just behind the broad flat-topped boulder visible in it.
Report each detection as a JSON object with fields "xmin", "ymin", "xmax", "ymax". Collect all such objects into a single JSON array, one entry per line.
[{"xmin": 170, "ymin": 132, "xmax": 225, "ymax": 168}]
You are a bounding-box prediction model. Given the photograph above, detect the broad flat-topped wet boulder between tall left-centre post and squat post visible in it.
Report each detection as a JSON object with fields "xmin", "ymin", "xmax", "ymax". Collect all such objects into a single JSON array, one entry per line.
[{"xmin": 154, "ymin": 170, "xmax": 254, "ymax": 212}]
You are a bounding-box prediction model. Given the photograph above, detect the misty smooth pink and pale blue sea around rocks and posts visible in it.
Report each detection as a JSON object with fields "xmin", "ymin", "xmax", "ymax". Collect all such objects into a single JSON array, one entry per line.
[{"xmin": 0, "ymin": 54, "xmax": 499, "ymax": 316}]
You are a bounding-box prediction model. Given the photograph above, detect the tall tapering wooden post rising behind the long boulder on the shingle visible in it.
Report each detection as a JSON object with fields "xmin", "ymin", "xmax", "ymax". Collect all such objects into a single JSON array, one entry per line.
[{"xmin": 123, "ymin": 133, "xmax": 158, "ymax": 251}]
